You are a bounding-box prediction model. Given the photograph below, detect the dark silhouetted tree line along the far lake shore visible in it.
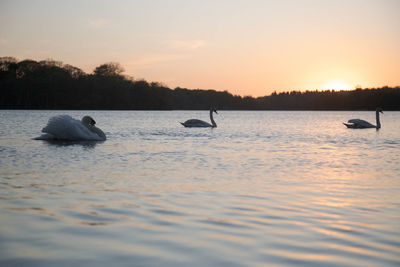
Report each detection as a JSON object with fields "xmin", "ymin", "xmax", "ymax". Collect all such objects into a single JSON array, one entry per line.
[{"xmin": 0, "ymin": 57, "xmax": 400, "ymax": 110}]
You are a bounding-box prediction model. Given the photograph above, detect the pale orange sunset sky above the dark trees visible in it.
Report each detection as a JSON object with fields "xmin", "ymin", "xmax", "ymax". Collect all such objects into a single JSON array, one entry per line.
[{"xmin": 0, "ymin": 0, "xmax": 400, "ymax": 96}]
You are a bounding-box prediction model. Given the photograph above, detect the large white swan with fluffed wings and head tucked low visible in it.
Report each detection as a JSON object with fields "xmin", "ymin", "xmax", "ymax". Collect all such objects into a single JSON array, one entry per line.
[{"xmin": 35, "ymin": 115, "xmax": 106, "ymax": 141}]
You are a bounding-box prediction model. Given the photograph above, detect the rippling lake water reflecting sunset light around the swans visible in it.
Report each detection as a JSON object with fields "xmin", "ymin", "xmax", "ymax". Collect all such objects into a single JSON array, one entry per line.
[{"xmin": 0, "ymin": 110, "xmax": 400, "ymax": 266}]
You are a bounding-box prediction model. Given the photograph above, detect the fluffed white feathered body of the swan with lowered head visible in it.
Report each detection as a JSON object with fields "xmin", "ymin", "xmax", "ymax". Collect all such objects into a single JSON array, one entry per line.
[{"xmin": 38, "ymin": 115, "xmax": 105, "ymax": 141}]
